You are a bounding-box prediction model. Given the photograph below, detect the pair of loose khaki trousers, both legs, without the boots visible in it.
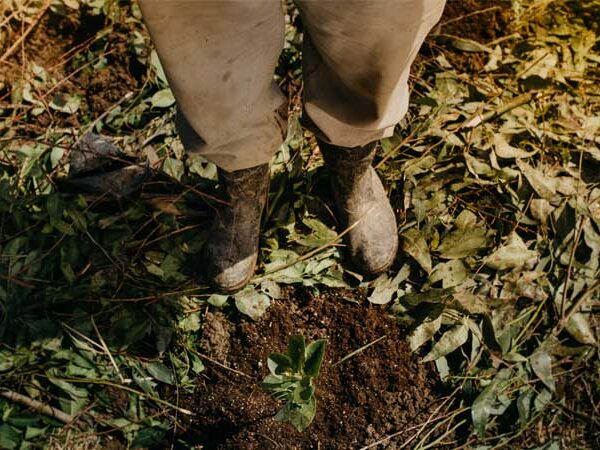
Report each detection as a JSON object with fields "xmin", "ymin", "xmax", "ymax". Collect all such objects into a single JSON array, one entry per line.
[{"xmin": 140, "ymin": 0, "xmax": 445, "ymax": 171}]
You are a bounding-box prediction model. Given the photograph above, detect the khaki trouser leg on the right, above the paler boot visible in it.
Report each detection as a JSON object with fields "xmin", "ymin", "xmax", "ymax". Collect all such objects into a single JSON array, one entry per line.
[{"xmin": 298, "ymin": 0, "xmax": 445, "ymax": 147}]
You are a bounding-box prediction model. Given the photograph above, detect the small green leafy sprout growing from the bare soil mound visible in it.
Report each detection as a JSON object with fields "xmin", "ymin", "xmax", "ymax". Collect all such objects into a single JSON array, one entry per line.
[{"xmin": 261, "ymin": 334, "xmax": 327, "ymax": 432}]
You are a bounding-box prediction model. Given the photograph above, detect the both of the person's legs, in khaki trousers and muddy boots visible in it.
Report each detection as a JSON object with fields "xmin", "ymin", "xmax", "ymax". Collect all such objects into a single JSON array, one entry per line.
[{"xmin": 140, "ymin": 0, "xmax": 445, "ymax": 290}]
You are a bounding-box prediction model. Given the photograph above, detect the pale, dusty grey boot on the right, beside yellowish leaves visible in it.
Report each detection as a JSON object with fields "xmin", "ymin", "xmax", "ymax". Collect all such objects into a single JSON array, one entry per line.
[{"xmin": 319, "ymin": 143, "xmax": 398, "ymax": 275}]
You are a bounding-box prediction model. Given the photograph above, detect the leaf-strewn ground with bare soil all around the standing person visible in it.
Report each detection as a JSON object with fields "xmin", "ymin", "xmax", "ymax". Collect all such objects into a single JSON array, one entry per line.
[{"xmin": 0, "ymin": 0, "xmax": 600, "ymax": 449}]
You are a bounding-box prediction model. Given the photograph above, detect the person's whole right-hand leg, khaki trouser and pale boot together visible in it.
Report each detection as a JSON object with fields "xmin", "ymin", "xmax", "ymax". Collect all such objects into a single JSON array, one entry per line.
[{"xmin": 297, "ymin": 0, "xmax": 445, "ymax": 274}]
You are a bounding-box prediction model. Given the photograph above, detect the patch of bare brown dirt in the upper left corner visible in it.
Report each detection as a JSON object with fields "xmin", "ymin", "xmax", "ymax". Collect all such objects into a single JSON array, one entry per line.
[{"xmin": 0, "ymin": 6, "xmax": 145, "ymax": 127}]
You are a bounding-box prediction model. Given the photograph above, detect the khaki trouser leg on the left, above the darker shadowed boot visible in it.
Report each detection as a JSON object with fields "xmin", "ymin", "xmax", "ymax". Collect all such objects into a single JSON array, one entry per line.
[{"xmin": 140, "ymin": 0, "xmax": 287, "ymax": 171}]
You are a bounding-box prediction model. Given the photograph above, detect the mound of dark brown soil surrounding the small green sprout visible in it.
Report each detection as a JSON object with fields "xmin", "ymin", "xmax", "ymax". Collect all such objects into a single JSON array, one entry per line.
[{"xmin": 179, "ymin": 289, "xmax": 439, "ymax": 449}]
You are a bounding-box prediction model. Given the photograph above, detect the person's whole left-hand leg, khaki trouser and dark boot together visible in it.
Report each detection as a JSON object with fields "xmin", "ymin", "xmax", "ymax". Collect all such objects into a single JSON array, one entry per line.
[{"xmin": 140, "ymin": 0, "xmax": 287, "ymax": 291}]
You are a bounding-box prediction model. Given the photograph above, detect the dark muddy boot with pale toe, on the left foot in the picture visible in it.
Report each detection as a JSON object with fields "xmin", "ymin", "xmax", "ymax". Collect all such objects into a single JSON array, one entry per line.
[{"xmin": 204, "ymin": 164, "xmax": 269, "ymax": 293}]
